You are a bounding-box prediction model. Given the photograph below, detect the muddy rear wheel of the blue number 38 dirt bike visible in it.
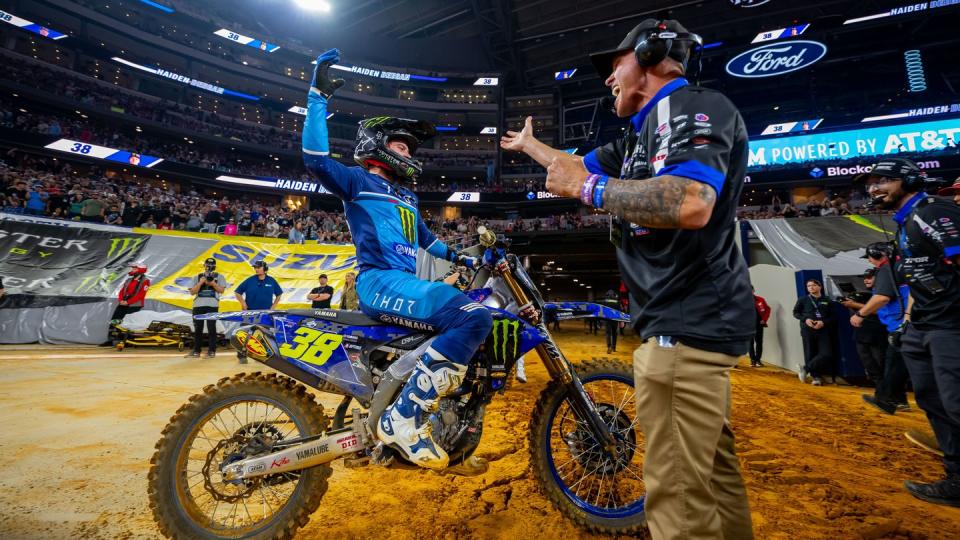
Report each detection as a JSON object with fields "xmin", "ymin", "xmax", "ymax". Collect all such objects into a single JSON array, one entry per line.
[{"xmin": 148, "ymin": 373, "xmax": 331, "ymax": 539}]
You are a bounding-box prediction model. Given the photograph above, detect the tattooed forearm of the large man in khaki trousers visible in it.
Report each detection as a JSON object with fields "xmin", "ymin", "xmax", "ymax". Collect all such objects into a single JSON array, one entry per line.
[{"xmin": 603, "ymin": 175, "xmax": 717, "ymax": 229}]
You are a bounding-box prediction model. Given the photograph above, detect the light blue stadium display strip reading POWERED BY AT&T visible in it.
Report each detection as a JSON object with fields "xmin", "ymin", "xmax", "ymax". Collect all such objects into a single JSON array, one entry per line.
[{"xmin": 748, "ymin": 118, "xmax": 960, "ymax": 167}]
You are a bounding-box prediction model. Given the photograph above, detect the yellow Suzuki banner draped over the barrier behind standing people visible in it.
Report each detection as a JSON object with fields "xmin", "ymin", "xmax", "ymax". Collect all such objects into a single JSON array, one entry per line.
[{"xmin": 147, "ymin": 242, "xmax": 356, "ymax": 311}]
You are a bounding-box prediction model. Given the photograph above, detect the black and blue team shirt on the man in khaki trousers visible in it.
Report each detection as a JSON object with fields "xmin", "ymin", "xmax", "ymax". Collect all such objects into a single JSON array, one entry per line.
[{"xmin": 583, "ymin": 78, "xmax": 756, "ymax": 355}]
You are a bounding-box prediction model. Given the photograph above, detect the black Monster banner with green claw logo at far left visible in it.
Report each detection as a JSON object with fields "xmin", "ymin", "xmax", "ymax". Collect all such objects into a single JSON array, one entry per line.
[{"xmin": 0, "ymin": 219, "xmax": 148, "ymax": 307}]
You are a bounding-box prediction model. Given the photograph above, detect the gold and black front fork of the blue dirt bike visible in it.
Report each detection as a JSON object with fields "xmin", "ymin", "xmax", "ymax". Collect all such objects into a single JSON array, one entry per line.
[{"xmin": 497, "ymin": 260, "xmax": 617, "ymax": 456}]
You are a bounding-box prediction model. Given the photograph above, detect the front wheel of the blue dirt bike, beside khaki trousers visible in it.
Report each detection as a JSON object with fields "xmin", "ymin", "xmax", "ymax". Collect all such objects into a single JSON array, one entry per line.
[{"xmin": 530, "ymin": 360, "xmax": 646, "ymax": 534}]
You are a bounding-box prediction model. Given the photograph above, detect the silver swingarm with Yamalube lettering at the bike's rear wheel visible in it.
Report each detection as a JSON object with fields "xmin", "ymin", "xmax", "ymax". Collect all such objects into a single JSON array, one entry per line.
[{"xmin": 222, "ymin": 428, "xmax": 363, "ymax": 482}]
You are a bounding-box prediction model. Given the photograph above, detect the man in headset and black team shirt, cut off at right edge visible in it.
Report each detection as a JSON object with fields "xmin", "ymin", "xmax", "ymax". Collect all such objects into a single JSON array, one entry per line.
[{"xmin": 854, "ymin": 158, "xmax": 960, "ymax": 506}]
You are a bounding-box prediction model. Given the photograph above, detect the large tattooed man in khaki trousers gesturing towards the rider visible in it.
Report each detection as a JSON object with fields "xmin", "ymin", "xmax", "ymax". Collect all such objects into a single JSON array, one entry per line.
[{"xmin": 501, "ymin": 19, "xmax": 755, "ymax": 540}]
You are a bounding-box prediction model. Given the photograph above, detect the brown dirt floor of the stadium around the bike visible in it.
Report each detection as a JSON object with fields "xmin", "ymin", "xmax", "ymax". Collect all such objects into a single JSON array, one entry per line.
[{"xmin": 0, "ymin": 325, "xmax": 960, "ymax": 539}]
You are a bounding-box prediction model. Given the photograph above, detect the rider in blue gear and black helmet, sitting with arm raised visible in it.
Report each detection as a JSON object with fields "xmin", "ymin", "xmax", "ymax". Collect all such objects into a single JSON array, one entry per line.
[{"xmin": 303, "ymin": 49, "xmax": 493, "ymax": 469}]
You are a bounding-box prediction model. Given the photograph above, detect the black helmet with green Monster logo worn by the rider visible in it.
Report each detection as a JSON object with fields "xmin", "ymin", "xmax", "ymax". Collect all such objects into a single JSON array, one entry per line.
[{"xmin": 353, "ymin": 116, "xmax": 437, "ymax": 182}]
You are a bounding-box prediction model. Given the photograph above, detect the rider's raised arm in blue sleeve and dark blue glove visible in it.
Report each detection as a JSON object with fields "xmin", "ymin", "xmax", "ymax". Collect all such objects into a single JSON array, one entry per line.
[{"xmin": 302, "ymin": 49, "xmax": 359, "ymax": 200}]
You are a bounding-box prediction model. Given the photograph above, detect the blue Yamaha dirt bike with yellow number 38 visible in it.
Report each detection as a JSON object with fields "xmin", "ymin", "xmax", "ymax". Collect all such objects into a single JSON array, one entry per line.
[{"xmin": 149, "ymin": 226, "xmax": 645, "ymax": 538}]
